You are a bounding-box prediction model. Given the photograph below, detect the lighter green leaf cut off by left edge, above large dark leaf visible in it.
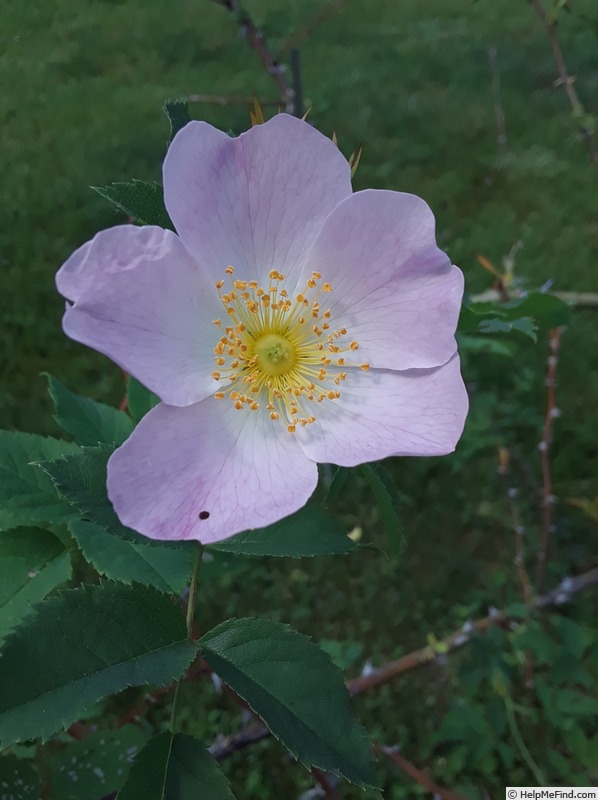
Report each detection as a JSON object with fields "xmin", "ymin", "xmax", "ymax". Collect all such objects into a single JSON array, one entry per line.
[{"xmin": 0, "ymin": 528, "xmax": 71, "ymax": 640}]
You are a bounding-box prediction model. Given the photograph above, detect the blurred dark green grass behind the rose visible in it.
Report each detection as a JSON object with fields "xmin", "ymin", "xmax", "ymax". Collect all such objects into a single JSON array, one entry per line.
[{"xmin": 0, "ymin": 0, "xmax": 598, "ymax": 798}]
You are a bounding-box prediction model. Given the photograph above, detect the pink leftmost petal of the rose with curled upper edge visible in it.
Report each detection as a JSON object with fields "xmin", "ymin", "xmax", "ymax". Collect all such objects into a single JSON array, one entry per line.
[{"xmin": 56, "ymin": 225, "xmax": 222, "ymax": 406}]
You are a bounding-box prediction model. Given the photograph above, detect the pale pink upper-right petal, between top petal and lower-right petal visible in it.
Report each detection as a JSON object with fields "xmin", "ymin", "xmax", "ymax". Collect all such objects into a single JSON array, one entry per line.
[{"xmin": 301, "ymin": 189, "xmax": 463, "ymax": 369}]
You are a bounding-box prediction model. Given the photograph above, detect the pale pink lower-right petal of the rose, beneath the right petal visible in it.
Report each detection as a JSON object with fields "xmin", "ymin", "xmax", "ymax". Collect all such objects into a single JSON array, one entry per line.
[{"xmin": 296, "ymin": 356, "xmax": 468, "ymax": 467}]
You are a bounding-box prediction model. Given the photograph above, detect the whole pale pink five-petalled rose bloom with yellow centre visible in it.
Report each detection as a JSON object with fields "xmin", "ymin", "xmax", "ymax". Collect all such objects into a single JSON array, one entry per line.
[{"xmin": 56, "ymin": 114, "xmax": 467, "ymax": 544}]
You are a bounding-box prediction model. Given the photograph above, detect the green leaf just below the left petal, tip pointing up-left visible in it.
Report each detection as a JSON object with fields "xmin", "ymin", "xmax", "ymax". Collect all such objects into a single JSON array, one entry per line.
[{"xmin": 45, "ymin": 373, "xmax": 134, "ymax": 446}]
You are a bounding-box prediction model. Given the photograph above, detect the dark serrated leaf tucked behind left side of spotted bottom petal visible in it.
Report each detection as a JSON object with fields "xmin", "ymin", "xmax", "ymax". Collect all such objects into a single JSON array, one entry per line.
[{"xmin": 40, "ymin": 444, "xmax": 188, "ymax": 549}]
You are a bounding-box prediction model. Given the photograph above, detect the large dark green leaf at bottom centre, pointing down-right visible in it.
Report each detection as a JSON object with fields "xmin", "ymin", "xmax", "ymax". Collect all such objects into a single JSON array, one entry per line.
[{"xmin": 199, "ymin": 618, "xmax": 377, "ymax": 787}]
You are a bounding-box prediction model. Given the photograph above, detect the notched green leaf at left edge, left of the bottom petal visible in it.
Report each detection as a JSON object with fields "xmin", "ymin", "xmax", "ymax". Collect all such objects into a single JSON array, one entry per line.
[{"xmin": 0, "ymin": 431, "xmax": 79, "ymax": 530}]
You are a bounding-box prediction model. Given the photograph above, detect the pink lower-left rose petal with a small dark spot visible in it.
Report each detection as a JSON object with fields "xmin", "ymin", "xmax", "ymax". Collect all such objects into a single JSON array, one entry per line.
[{"xmin": 108, "ymin": 398, "xmax": 318, "ymax": 544}]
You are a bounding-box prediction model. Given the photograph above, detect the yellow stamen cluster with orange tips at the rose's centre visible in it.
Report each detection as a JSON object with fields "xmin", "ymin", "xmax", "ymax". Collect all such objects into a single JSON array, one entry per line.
[{"xmin": 212, "ymin": 267, "xmax": 369, "ymax": 433}]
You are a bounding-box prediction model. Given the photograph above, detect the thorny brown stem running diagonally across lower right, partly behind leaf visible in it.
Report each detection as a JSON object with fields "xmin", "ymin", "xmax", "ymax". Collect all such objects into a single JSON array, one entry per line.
[{"xmin": 209, "ymin": 567, "xmax": 598, "ymax": 761}]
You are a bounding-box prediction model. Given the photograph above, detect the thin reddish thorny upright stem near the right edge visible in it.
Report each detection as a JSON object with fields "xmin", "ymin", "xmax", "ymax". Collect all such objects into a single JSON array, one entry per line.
[{"xmin": 536, "ymin": 328, "xmax": 562, "ymax": 592}]
